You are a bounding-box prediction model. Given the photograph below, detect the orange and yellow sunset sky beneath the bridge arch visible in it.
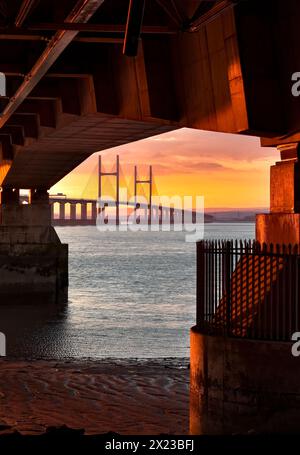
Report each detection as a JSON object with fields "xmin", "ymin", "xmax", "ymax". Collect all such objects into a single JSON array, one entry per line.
[{"xmin": 51, "ymin": 128, "xmax": 279, "ymax": 208}]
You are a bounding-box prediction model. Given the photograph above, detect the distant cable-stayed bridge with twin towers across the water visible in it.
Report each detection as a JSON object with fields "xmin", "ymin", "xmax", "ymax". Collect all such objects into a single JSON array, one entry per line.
[{"xmin": 50, "ymin": 155, "xmax": 202, "ymax": 226}]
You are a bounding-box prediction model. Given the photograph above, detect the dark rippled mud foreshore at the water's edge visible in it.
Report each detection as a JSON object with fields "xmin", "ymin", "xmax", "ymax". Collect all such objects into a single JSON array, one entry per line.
[{"xmin": 0, "ymin": 359, "xmax": 189, "ymax": 434}]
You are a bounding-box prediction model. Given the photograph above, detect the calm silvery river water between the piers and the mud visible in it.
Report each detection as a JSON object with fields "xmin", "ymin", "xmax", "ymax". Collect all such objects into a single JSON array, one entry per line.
[{"xmin": 0, "ymin": 223, "xmax": 254, "ymax": 359}]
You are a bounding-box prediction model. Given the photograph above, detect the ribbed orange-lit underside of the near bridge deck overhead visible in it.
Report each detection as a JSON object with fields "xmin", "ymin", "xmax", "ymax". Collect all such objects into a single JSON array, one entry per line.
[{"xmin": 0, "ymin": 0, "xmax": 254, "ymax": 188}]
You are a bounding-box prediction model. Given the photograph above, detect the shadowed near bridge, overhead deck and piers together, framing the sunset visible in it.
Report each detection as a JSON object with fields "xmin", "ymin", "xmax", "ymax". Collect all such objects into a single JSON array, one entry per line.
[{"xmin": 0, "ymin": 0, "xmax": 300, "ymax": 434}]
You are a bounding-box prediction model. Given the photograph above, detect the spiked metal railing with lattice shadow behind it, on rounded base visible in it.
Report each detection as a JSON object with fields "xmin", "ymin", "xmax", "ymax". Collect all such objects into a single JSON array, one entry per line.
[{"xmin": 197, "ymin": 240, "xmax": 300, "ymax": 341}]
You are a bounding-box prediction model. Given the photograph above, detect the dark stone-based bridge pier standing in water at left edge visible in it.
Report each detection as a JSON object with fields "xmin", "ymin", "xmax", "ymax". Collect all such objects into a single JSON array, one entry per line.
[{"xmin": 0, "ymin": 188, "xmax": 68, "ymax": 304}]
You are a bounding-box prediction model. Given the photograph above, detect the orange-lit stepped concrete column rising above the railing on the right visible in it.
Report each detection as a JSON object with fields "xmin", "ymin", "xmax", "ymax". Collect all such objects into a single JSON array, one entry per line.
[{"xmin": 256, "ymin": 143, "xmax": 300, "ymax": 244}]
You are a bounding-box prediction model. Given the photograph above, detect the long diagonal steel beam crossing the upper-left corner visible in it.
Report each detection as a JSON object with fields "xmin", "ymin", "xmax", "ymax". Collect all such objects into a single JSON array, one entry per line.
[{"xmin": 0, "ymin": 0, "xmax": 104, "ymax": 128}]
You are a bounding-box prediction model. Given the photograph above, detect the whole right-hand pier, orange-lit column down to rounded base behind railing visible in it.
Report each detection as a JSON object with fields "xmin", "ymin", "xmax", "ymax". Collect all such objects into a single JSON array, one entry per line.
[{"xmin": 190, "ymin": 143, "xmax": 300, "ymax": 434}]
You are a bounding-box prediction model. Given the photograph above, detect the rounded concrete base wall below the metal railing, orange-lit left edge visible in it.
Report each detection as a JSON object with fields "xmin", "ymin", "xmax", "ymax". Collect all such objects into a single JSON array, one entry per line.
[{"xmin": 190, "ymin": 328, "xmax": 300, "ymax": 434}]
